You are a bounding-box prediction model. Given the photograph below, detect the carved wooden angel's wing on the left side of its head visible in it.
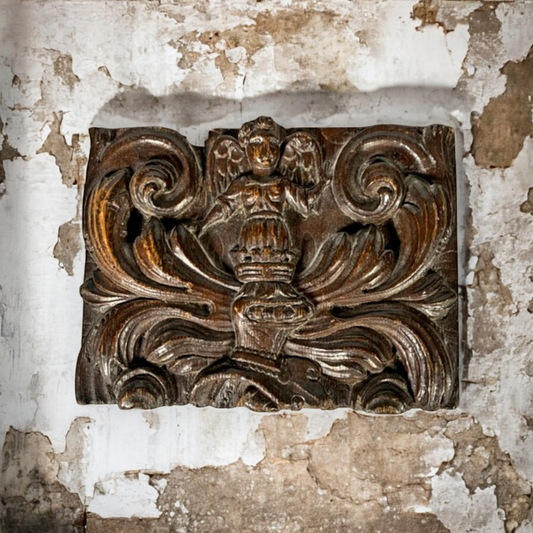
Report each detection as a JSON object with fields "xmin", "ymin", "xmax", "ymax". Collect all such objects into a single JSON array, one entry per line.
[{"xmin": 204, "ymin": 132, "xmax": 251, "ymax": 209}]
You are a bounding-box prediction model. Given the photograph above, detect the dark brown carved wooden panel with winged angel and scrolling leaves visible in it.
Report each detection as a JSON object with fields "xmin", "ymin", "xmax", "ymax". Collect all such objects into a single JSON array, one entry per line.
[{"xmin": 76, "ymin": 117, "xmax": 457, "ymax": 413}]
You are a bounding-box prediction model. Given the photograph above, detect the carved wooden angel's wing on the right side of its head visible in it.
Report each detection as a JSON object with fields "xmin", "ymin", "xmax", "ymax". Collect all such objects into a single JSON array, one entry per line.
[{"xmin": 279, "ymin": 131, "xmax": 326, "ymax": 188}]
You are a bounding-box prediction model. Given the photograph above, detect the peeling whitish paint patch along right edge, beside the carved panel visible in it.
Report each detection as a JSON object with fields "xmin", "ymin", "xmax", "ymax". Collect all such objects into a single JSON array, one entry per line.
[{"xmin": 461, "ymin": 138, "xmax": 533, "ymax": 479}]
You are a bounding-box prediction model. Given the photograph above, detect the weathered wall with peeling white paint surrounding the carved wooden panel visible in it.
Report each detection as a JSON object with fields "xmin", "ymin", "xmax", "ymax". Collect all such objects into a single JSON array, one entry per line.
[{"xmin": 0, "ymin": 0, "xmax": 533, "ymax": 533}]
